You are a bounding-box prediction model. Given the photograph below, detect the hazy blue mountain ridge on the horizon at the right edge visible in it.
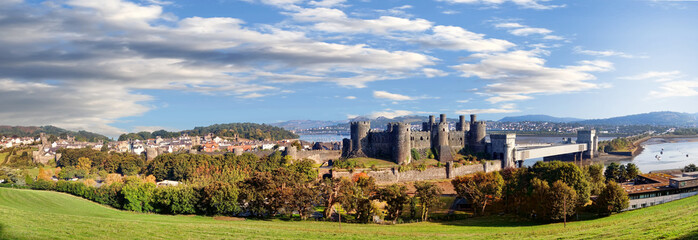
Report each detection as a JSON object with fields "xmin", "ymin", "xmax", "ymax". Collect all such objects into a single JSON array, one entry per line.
[{"xmin": 579, "ymin": 112, "xmax": 698, "ymax": 127}]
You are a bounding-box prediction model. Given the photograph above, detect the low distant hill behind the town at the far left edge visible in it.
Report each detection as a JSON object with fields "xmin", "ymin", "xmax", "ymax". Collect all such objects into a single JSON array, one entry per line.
[{"xmin": 0, "ymin": 125, "xmax": 111, "ymax": 142}]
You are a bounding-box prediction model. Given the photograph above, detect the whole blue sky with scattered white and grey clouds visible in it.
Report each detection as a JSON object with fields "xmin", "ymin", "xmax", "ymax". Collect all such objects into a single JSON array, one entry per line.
[{"xmin": 0, "ymin": 0, "xmax": 698, "ymax": 136}]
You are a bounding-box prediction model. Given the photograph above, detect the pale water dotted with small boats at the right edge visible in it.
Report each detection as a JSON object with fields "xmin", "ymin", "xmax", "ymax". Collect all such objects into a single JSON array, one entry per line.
[{"xmin": 620, "ymin": 139, "xmax": 698, "ymax": 173}]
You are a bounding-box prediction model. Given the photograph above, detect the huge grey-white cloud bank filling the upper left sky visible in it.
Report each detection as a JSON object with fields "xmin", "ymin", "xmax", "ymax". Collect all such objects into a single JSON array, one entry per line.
[{"xmin": 0, "ymin": 0, "xmax": 436, "ymax": 134}]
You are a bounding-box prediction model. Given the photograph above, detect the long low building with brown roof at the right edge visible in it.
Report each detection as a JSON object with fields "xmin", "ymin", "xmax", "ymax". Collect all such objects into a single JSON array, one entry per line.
[{"xmin": 621, "ymin": 173, "xmax": 698, "ymax": 210}]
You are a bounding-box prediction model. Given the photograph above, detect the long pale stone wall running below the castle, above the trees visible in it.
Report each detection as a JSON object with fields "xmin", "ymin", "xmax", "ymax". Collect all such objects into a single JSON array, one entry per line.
[{"xmin": 331, "ymin": 161, "xmax": 502, "ymax": 184}]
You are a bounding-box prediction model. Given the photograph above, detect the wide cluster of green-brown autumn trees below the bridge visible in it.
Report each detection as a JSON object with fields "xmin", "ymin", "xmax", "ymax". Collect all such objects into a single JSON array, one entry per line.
[{"xmin": 452, "ymin": 161, "xmax": 629, "ymax": 221}]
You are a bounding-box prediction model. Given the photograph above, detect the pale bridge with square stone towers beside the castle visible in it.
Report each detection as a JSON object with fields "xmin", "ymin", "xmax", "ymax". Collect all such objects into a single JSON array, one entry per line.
[{"xmin": 488, "ymin": 130, "xmax": 598, "ymax": 168}]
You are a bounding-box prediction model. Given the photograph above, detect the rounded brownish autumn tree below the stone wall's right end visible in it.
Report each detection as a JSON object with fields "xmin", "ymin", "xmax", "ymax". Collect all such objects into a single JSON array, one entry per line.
[{"xmin": 451, "ymin": 172, "xmax": 504, "ymax": 215}]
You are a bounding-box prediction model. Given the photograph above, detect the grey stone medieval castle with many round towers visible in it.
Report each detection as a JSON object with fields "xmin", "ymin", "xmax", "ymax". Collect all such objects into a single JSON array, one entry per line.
[{"xmin": 342, "ymin": 114, "xmax": 487, "ymax": 164}]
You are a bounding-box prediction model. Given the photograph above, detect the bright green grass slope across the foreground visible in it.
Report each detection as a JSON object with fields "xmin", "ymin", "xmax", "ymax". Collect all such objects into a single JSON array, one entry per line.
[{"xmin": 0, "ymin": 188, "xmax": 698, "ymax": 239}]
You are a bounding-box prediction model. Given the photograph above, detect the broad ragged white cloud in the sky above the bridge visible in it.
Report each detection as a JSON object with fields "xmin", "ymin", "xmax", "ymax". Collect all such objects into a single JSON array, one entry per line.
[{"xmin": 453, "ymin": 49, "xmax": 613, "ymax": 103}]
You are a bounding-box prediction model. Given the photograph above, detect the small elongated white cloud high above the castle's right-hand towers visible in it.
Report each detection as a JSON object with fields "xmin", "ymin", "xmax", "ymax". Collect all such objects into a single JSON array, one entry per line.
[{"xmin": 412, "ymin": 25, "xmax": 516, "ymax": 52}]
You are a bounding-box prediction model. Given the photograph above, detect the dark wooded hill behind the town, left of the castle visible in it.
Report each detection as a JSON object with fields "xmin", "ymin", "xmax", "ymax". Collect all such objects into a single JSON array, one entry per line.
[{"xmin": 119, "ymin": 123, "xmax": 299, "ymax": 141}]
